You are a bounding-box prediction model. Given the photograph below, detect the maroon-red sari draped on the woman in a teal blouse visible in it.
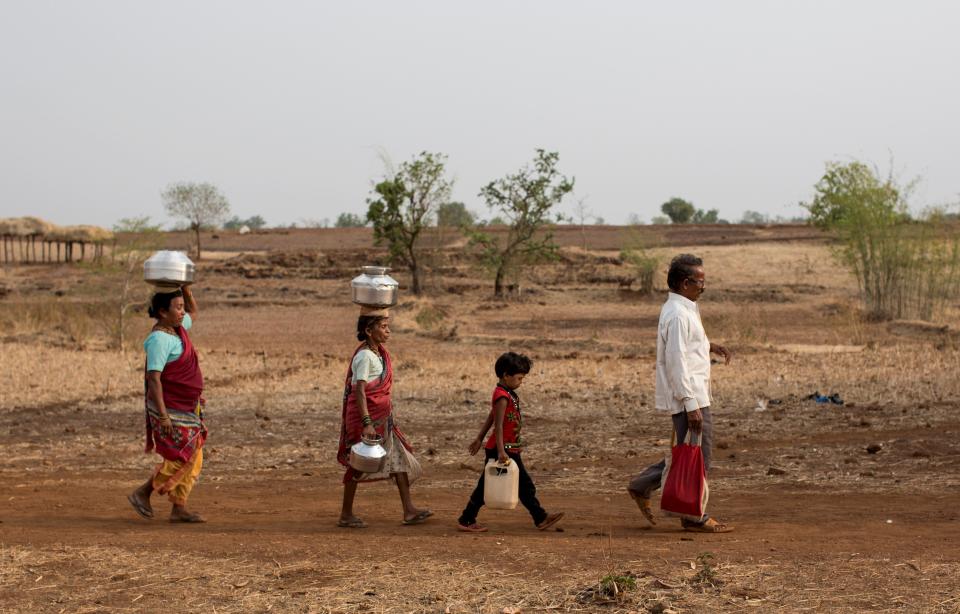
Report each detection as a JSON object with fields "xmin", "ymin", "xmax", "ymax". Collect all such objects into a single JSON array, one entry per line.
[{"xmin": 144, "ymin": 326, "xmax": 207, "ymax": 467}]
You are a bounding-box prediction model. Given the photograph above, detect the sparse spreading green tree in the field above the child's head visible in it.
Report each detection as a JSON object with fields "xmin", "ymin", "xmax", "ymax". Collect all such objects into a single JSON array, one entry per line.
[{"xmin": 471, "ymin": 149, "xmax": 574, "ymax": 296}]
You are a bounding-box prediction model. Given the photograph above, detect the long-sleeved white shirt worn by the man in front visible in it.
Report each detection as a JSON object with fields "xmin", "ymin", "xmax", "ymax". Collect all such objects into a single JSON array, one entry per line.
[{"xmin": 656, "ymin": 292, "xmax": 710, "ymax": 414}]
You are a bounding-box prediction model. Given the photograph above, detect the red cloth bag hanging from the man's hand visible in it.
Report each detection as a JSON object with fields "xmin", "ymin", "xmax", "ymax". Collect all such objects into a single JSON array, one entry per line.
[{"xmin": 660, "ymin": 431, "xmax": 710, "ymax": 520}]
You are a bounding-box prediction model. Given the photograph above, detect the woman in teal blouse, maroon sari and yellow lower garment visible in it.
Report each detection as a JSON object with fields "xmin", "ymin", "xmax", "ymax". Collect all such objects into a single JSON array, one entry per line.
[{"xmin": 127, "ymin": 286, "xmax": 207, "ymax": 522}]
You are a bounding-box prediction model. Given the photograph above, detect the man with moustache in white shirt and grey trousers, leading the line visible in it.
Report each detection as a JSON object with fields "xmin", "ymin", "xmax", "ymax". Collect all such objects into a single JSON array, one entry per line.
[{"xmin": 627, "ymin": 254, "xmax": 733, "ymax": 533}]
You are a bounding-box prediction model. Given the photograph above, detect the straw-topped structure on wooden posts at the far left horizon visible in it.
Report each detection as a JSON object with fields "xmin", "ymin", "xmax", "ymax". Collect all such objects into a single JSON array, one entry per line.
[{"xmin": 0, "ymin": 217, "xmax": 114, "ymax": 264}]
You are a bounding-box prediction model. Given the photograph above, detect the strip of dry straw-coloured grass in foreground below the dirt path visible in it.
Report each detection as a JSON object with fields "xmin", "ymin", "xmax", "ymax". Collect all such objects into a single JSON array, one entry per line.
[{"xmin": 0, "ymin": 546, "xmax": 960, "ymax": 613}]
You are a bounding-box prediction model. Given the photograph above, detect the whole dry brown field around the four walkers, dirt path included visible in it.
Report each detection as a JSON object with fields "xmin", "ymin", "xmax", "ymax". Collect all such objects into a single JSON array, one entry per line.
[{"xmin": 0, "ymin": 227, "xmax": 960, "ymax": 613}]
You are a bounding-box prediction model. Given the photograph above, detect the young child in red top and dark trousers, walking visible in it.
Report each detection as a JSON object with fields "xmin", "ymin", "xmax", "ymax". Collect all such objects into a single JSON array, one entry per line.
[{"xmin": 457, "ymin": 352, "xmax": 563, "ymax": 533}]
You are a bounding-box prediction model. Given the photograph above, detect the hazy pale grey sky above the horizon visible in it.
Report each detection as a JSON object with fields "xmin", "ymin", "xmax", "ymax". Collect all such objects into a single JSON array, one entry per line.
[{"xmin": 0, "ymin": 0, "xmax": 960, "ymax": 226}]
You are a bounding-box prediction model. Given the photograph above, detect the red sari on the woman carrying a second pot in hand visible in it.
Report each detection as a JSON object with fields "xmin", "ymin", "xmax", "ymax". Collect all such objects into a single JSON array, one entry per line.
[{"xmin": 337, "ymin": 344, "xmax": 413, "ymax": 484}]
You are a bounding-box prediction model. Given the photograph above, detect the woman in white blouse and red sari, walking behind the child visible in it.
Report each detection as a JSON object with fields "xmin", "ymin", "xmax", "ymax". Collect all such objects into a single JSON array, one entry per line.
[{"xmin": 337, "ymin": 310, "xmax": 433, "ymax": 529}]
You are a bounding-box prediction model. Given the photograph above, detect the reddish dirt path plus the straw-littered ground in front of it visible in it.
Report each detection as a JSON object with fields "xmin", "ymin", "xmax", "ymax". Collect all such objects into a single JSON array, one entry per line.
[{"xmin": 0, "ymin": 471, "xmax": 960, "ymax": 611}]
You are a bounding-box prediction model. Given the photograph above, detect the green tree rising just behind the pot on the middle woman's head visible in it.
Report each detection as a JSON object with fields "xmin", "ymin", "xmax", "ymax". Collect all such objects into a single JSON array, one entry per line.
[{"xmin": 367, "ymin": 151, "xmax": 453, "ymax": 295}]
